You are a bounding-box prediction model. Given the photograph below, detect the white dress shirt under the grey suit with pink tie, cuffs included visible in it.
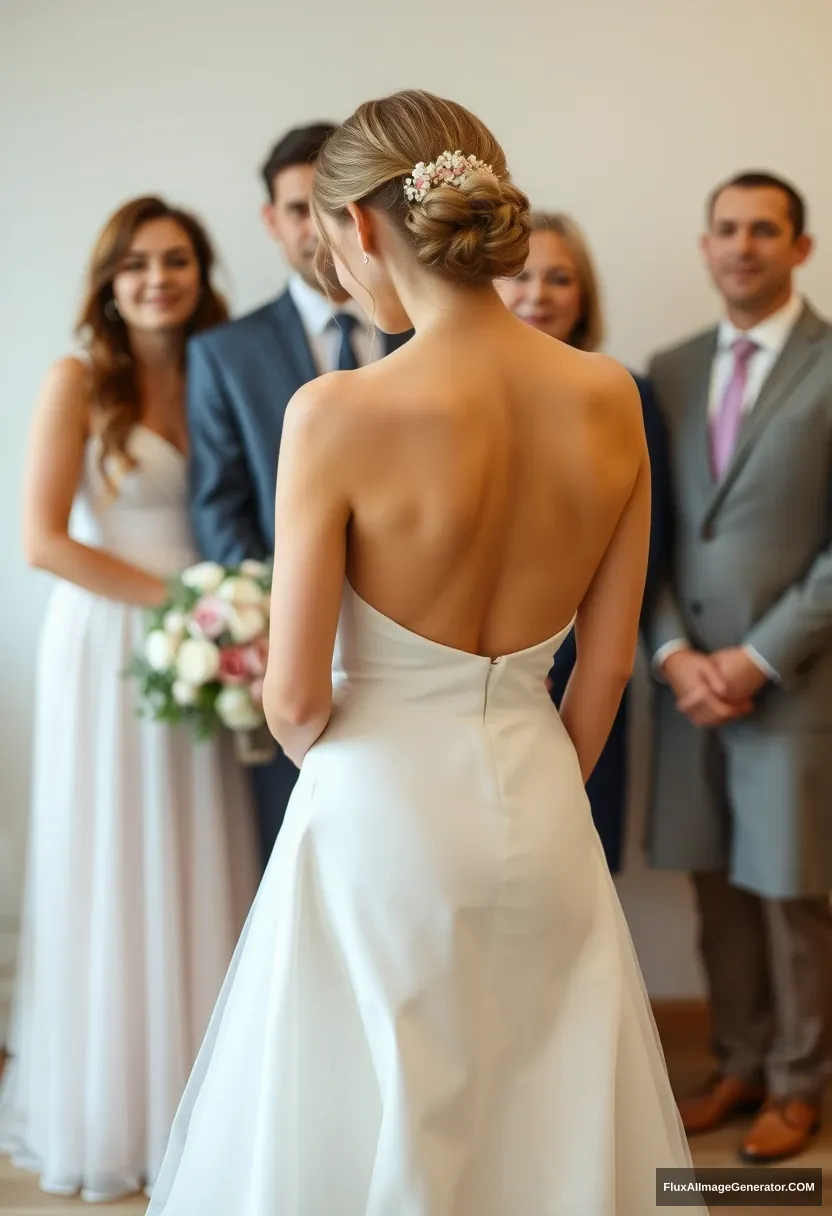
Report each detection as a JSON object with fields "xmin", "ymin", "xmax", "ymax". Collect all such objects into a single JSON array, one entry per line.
[{"xmin": 653, "ymin": 286, "xmax": 804, "ymax": 682}]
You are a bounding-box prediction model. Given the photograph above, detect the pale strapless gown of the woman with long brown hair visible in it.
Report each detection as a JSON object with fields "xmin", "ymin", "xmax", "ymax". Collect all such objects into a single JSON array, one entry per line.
[{"xmin": 0, "ymin": 426, "xmax": 258, "ymax": 1200}]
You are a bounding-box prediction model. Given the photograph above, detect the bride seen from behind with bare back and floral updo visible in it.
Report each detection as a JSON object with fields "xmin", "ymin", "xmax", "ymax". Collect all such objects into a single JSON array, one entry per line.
[{"xmin": 148, "ymin": 92, "xmax": 702, "ymax": 1216}]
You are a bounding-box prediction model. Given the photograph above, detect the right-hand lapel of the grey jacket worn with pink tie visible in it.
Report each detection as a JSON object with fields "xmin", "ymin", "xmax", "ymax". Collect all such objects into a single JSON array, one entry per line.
[{"xmin": 703, "ymin": 305, "xmax": 825, "ymax": 524}]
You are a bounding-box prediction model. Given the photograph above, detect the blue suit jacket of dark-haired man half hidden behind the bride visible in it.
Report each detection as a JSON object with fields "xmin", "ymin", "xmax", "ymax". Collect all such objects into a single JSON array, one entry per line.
[{"xmin": 187, "ymin": 292, "xmax": 410, "ymax": 565}]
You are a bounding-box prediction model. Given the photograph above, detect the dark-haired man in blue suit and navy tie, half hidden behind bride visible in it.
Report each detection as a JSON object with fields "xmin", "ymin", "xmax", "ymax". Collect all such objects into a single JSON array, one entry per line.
[{"xmin": 187, "ymin": 123, "xmax": 406, "ymax": 867}]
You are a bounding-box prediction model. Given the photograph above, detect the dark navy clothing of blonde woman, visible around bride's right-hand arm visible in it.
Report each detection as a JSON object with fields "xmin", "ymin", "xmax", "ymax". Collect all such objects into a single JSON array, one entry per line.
[{"xmin": 550, "ymin": 376, "xmax": 673, "ymax": 873}]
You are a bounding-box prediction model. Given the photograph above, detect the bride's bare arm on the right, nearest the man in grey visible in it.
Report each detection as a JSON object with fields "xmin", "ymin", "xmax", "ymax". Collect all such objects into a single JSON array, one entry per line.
[{"xmin": 561, "ymin": 372, "xmax": 651, "ymax": 781}]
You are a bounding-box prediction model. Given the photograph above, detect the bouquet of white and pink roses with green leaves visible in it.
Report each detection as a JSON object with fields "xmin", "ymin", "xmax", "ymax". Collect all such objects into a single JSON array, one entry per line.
[{"xmin": 128, "ymin": 562, "xmax": 276, "ymax": 764}]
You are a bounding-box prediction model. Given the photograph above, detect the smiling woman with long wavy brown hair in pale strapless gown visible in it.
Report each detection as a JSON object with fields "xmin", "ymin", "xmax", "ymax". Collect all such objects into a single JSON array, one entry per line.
[{"xmin": 0, "ymin": 197, "xmax": 257, "ymax": 1200}]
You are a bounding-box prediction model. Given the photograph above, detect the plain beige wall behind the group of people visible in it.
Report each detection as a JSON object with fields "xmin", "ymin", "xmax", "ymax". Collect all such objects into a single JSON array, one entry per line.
[{"xmin": 0, "ymin": 0, "xmax": 832, "ymax": 1029}]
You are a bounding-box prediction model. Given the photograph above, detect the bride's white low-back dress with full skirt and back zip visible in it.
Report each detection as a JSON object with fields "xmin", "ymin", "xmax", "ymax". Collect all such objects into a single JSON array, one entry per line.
[{"xmin": 148, "ymin": 586, "xmax": 704, "ymax": 1216}]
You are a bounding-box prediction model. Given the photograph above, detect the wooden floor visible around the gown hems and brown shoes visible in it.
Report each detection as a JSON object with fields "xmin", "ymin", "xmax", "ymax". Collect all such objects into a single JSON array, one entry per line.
[{"xmin": 0, "ymin": 1006, "xmax": 832, "ymax": 1216}]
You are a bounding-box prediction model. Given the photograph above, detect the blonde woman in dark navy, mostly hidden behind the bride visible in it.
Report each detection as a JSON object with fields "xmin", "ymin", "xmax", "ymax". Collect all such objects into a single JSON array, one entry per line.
[{"xmin": 497, "ymin": 212, "xmax": 673, "ymax": 873}]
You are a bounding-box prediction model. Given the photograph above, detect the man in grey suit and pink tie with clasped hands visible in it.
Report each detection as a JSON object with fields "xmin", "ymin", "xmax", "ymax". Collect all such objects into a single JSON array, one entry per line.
[{"xmin": 647, "ymin": 173, "xmax": 832, "ymax": 1161}]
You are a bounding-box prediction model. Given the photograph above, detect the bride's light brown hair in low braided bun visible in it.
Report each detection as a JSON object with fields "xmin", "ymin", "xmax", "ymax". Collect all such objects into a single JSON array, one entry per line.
[{"xmin": 313, "ymin": 90, "xmax": 532, "ymax": 286}]
